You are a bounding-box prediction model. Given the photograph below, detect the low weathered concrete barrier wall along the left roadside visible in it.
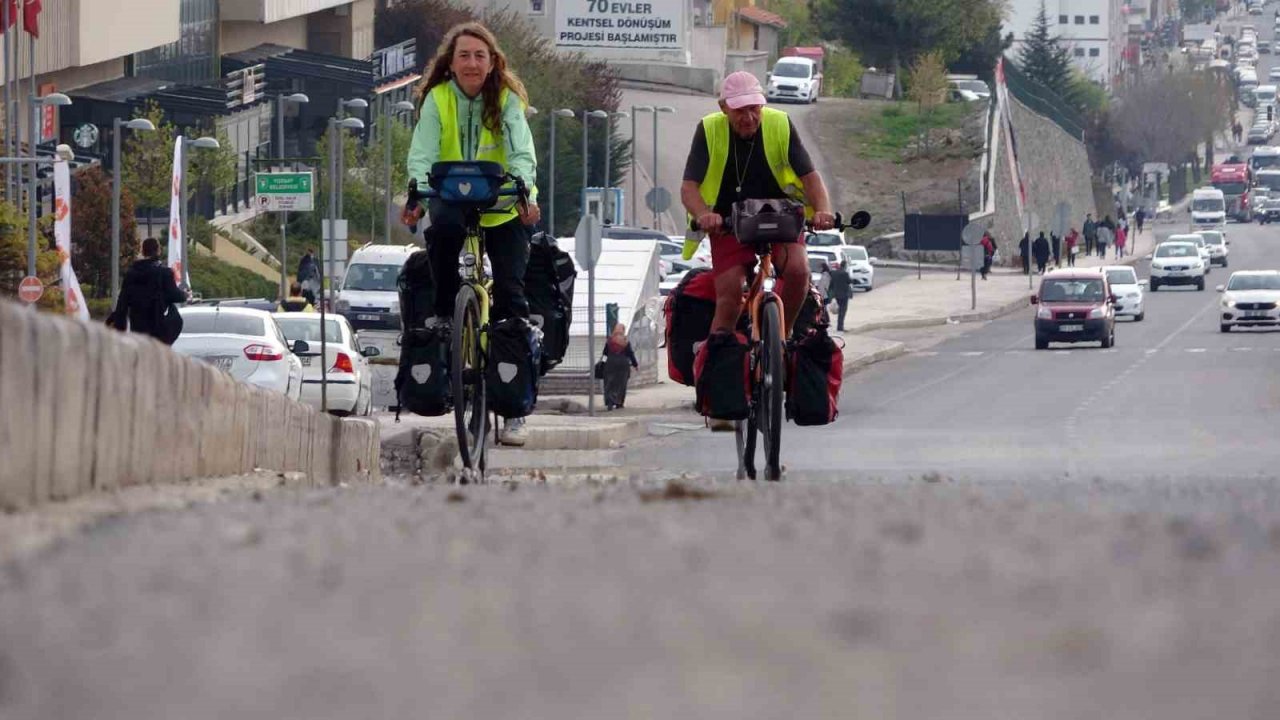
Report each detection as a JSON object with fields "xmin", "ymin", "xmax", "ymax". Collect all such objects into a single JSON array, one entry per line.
[{"xmin": 0, "ymin": 300, "xmax": 380, "ymax": 510}]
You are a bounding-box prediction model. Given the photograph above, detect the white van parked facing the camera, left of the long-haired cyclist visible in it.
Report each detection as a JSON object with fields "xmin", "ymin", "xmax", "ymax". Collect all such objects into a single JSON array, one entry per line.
[{"xmin": 334, "ymin": 243, "xmax": 419, "ymax": 334}]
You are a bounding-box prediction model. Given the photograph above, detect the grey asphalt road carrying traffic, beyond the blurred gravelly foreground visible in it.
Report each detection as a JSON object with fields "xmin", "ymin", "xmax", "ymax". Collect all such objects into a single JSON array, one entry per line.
[{"xmin": 632, "ymin": 219, "xmax": 1280, "ymax": 482}]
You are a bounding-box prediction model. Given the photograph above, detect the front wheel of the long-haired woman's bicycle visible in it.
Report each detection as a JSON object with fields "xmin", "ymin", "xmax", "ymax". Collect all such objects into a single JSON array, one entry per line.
[{"xmin": 451, "ymin": 284, "xmax": 485, "ymax": 474}]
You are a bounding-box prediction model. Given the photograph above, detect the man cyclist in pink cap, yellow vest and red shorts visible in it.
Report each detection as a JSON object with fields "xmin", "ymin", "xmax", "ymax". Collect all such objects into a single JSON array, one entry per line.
[{"xmin": 680, "ymin": 70, "xmax": 836, "ymax": 332}]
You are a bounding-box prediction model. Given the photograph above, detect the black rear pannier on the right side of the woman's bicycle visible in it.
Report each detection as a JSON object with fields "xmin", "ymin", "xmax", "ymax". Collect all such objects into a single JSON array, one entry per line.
[{"xmin": 525, "ymin": 232, "xmax": 577, "ymax": 375}]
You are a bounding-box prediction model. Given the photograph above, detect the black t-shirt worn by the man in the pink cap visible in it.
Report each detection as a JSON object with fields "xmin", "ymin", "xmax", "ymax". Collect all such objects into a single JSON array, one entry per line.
[{"xmin": 685, "ymin": 118, "xmax": 813, "ymax": 215}]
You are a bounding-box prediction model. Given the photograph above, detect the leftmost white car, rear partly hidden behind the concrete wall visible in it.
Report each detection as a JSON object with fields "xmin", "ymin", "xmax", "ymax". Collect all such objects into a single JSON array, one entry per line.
[{"xmin": 173, "ymin": 306, "xmax": 311, "ymax": 400}]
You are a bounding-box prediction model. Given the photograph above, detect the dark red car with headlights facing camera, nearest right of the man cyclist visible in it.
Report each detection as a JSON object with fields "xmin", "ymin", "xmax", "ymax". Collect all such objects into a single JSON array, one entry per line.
[{"xmin": 1032, "ymin": 268, "xmax": 1116, "ymax": 350}]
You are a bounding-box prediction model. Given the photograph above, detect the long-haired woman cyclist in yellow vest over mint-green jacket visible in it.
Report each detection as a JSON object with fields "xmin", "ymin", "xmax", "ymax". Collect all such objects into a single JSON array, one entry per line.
[{"xmin": 402, "ymin": 23, "xmax": 541, "ymax": 445}]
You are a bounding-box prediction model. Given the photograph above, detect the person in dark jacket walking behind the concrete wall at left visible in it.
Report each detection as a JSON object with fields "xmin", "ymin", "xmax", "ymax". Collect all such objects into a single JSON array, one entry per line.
[{"xmin": 108, "ymin": 237, "xmax": 187, "ymax": 345}]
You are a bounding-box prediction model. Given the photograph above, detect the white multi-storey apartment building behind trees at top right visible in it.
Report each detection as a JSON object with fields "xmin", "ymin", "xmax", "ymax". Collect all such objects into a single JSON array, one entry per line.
[{"xmin": 1005, "ymin": 0, "xmax": 1129, "ymax": 90}]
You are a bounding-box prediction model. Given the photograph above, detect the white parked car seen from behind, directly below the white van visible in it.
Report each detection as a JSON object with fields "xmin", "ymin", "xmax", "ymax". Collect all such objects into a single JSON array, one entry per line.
[{"xmin": 275, "ymin": 313, "xmax": 381, "ymax": 415}]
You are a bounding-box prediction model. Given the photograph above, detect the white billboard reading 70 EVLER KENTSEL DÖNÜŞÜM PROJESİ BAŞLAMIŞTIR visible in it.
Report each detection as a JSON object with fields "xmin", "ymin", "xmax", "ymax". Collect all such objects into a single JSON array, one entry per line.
[{"xmin": 556, "ymin": 0, "xmax": 687, "ymax": 51}]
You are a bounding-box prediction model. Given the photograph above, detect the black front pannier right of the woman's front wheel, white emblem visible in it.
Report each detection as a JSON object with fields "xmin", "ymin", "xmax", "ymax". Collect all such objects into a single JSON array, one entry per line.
[{"xmin": 485, "ymin": 318, "xmax": 541, "ymax": 418}]
